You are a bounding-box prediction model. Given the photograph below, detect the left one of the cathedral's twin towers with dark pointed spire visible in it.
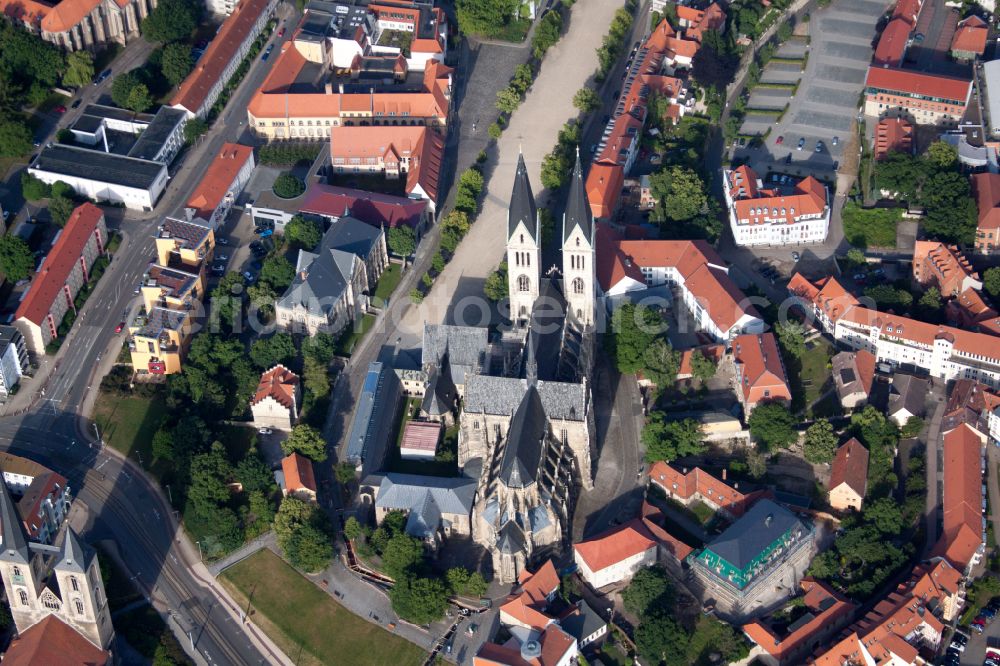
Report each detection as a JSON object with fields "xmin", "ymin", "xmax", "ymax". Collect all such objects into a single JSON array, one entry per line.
[{"xmin": 507, "ymin": 154, "xmax": 542, "ymax": 327}]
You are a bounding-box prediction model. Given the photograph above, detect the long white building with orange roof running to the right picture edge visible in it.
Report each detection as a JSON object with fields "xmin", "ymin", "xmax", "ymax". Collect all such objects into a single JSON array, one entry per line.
[{"xmin": 788, "ymin": 273, "xmax": 1000, "ymax": 389}]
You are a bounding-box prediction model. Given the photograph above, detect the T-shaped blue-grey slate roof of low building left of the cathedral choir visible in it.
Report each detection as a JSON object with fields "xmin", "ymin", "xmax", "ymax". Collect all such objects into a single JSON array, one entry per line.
[{"xmin": 375, "ymin": 474, "xmax": 477, "ymax": 538}]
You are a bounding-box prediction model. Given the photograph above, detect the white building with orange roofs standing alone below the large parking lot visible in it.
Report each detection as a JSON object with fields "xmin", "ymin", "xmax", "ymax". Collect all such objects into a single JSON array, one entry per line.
[{"xmin": 722, "ymin": 166, "xmax": 830, "ymax": 246}]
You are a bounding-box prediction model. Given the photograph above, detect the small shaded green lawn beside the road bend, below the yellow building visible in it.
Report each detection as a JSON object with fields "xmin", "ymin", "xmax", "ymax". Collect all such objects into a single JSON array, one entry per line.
[{"xmin": 94, "ymin": 393, "xmax": 166, "ymax": 478}]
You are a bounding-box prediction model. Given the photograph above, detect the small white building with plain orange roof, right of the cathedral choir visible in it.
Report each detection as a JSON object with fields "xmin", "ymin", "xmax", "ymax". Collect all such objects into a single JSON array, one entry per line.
[{"xmin": 573, "ymin": 518, "xmax": 657, "ymax": 590}]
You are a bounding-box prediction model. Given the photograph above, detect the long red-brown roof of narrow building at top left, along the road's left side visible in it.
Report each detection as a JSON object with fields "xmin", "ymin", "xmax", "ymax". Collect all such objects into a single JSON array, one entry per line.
[{"xmin": 170, "ymin": 0, "xmax": 271, "ymax": 113}]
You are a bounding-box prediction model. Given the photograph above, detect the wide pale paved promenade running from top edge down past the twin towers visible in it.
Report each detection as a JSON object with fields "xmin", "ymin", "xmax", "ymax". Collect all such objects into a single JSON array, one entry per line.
[{"xmin": 398, "ymin": 0, "xmax": 622, "ymax": 339}]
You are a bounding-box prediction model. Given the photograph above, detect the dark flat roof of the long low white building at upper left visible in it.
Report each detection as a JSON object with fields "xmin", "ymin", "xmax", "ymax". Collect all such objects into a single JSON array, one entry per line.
[{"xmin": 28, "ymin": 144, "xmax": 167, "ymax": 190}]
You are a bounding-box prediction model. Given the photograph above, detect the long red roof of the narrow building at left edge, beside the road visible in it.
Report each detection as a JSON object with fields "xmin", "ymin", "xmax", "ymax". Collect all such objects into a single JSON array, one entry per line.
[{"xmin": 14, "ymin": 203, "xmax": 104, "ymax": 326}]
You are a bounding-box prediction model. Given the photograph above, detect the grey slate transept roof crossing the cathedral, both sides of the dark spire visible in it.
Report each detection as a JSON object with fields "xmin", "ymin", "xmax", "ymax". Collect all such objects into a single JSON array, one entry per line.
[{"xmin": 464, "ymin": 375, "xmax": 587, "ymax": 421}]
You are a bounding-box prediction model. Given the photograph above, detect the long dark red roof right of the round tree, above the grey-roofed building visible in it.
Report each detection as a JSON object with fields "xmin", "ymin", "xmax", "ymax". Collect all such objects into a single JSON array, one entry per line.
[{"xmin": 299, "ymin": 184, "xmax": 427, "ymax": 228}]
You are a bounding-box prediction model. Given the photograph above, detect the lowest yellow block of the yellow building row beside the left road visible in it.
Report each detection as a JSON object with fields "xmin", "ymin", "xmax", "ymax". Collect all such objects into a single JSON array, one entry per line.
[{"xmin": 129, "ymin": 307, "xmax": 191, "ymax": 375}]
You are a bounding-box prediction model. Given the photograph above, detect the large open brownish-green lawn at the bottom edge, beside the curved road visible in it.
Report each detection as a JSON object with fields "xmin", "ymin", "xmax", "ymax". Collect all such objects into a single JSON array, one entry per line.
[{"xmin": 219, "ymin": 550, "xmax": 426, "ymax": 666}]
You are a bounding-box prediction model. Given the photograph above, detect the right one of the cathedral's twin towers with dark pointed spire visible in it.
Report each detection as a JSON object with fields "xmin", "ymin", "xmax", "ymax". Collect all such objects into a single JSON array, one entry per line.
[{"xmin": 562, "ymin": 148, "xmax": 596, "ymax": 329}]
